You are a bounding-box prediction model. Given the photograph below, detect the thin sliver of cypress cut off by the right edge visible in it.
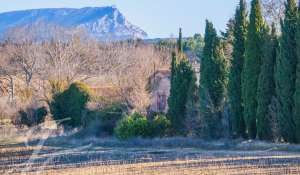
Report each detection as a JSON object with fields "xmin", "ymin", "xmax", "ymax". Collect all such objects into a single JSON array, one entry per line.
[{"xmin": 294, "ymin": 1, "xmax": 300, "ymax": 143}]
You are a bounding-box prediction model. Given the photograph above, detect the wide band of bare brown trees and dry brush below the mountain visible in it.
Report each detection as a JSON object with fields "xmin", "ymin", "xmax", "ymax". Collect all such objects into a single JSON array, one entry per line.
[{"xmin": 0, "ymin": 29, "xmax": 169, "ymax": 125}]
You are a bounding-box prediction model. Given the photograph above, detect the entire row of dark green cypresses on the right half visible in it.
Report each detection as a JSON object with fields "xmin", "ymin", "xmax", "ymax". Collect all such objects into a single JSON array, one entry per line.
[{"xmin": 168, "ymin": 0, "xmax": 300, "ymax": 143}]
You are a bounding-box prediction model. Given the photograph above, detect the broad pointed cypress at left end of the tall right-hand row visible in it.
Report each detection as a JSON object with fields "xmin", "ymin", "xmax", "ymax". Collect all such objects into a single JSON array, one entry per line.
[{"xmin": 200, "ymin": 21, "xmax": 227, "ymax": 137}]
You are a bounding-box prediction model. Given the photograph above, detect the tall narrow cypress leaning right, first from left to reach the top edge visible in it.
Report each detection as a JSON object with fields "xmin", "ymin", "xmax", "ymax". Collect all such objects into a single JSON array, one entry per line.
[{"xmin": 228, "ymin": 0, "xmax": 247, "ymax": 138}]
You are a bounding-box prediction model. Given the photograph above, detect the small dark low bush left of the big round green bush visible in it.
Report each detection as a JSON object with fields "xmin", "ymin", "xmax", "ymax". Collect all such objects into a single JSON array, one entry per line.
[{"xmin": 16, "ymin": 106, "xmax": 48, "ymax": 127}]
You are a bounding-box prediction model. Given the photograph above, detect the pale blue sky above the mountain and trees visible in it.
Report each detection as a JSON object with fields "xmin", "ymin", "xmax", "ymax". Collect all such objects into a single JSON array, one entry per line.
[{"xmin": 0, "ymin": 0, "xmax": 239, "ymax": 38}]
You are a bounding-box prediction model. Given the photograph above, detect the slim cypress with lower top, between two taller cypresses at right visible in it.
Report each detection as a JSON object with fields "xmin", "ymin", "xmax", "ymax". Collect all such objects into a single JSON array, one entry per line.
[{"xmin": 256, "ymin": 24, "xmax": 278, "ymax": 140}]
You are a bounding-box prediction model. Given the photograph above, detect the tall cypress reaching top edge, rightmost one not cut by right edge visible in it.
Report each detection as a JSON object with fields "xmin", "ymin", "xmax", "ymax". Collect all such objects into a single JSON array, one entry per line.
[{"xmin": 275, "ymin": 0, "xmax": 297, "ymax": 142}]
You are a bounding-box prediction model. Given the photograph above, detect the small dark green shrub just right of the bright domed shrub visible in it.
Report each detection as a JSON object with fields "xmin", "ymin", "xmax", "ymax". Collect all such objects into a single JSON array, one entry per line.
[{"xmin": 152, "ymin": 115, "xmax": 171, "ymax": 137}]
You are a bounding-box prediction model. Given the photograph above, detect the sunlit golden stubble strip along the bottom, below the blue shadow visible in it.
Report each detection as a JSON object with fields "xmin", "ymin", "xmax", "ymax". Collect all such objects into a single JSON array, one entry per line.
[{"xmin": 5, "ymin": 156, "xmax": 300, "ymax": 175}]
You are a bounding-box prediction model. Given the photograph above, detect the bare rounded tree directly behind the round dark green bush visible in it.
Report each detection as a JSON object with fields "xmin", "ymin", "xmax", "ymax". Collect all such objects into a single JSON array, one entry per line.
[{"xmin": 43, "ymin": 38, "xmax": 95, "ymax": 83}]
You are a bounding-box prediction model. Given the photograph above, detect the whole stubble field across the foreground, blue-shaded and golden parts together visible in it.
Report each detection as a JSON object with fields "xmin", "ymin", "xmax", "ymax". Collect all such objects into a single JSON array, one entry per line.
[{"xmin": 0, "ymin": 138, "xmax": 300, "ymax": 175}]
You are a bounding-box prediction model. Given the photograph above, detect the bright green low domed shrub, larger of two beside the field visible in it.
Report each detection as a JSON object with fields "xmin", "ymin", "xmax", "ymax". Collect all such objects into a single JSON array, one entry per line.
[{"xmin": 115, "ymin": 113, "xmax": 153, "ymax": 139}]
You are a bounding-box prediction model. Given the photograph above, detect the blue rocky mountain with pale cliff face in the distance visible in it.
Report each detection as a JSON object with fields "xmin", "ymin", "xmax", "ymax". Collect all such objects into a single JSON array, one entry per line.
[{"xmin": 0, "ymin": 7, "xmax": 147, "ymax": 40}]
